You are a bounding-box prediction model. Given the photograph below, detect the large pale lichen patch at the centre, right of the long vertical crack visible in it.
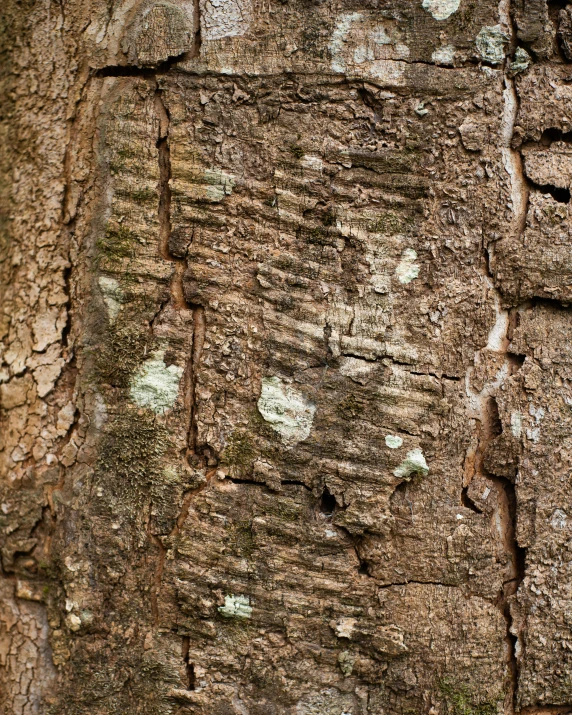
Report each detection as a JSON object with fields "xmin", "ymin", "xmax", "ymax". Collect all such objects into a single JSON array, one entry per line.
[{"xmin": 258, "ymin": 377, "xmax": 316, "ymax": 447}]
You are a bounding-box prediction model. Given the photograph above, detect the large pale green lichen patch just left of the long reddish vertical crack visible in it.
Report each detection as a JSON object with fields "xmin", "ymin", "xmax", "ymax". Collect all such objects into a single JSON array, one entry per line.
[{"xmin": 130, "ymin": 350, "xmax": 184, "ymax": 414}]
